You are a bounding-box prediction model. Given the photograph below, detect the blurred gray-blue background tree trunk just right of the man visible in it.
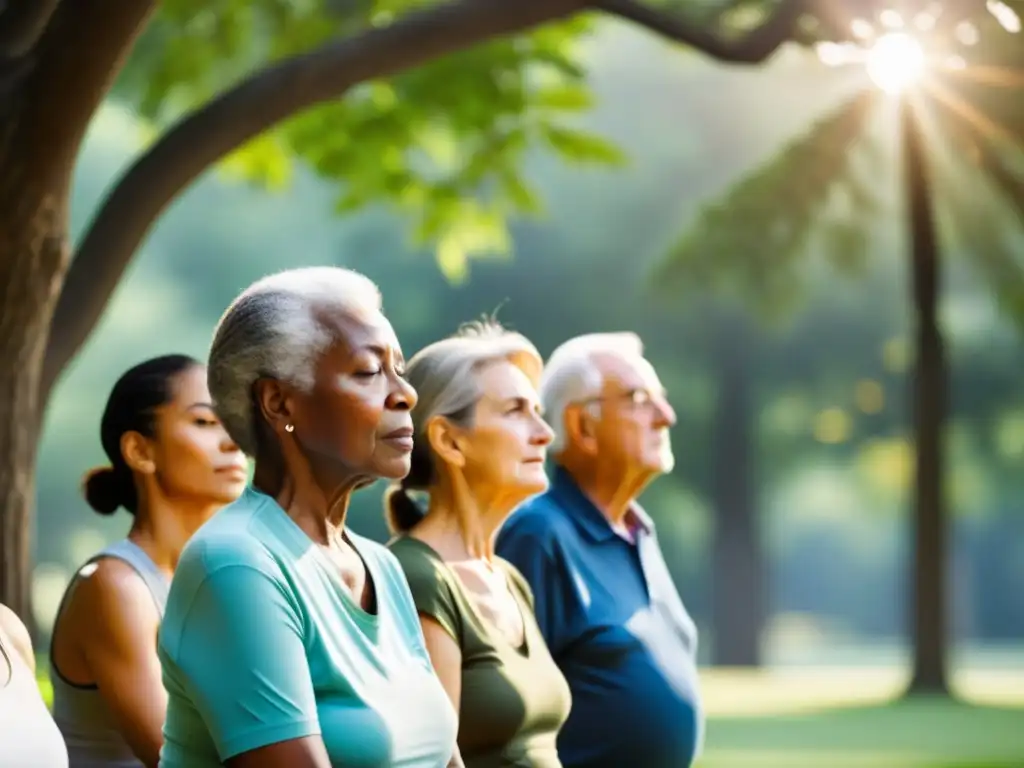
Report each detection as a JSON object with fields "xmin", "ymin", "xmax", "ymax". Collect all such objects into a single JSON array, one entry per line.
[{"xmin": 712, "ymin": 309, "xmax": 766, "ymax": 667}]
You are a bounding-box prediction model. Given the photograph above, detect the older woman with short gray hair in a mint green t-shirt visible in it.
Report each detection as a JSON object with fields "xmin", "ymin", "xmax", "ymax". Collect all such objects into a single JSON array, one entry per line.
[{"xmin": 159, "ymin": 267, "xmax": 457, "ymax": 768}]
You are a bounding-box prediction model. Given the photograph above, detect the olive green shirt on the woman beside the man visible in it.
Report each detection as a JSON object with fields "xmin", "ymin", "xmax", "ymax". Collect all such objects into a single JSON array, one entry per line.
[{"xmin": 389, "ymin": 537, "xmax": 571, "ymax": 768}]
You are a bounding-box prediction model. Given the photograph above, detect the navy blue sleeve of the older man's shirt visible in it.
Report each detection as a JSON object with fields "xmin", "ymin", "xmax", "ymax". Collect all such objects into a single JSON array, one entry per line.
[{"xmin": 498, "ymin": 521, "xmax": 585, "ymax": 653}]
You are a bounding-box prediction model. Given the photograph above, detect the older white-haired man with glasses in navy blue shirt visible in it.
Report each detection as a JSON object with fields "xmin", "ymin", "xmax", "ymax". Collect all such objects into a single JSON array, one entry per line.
[{"xmin": 498, "ymin": 333, "xmax": 703, "ymax": 768}]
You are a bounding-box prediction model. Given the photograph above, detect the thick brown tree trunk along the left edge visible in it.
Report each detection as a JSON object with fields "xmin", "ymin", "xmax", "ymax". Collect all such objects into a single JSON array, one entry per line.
[{"xmin": 0, "ymin": 0, "xmax": 155, "ymax": 626}]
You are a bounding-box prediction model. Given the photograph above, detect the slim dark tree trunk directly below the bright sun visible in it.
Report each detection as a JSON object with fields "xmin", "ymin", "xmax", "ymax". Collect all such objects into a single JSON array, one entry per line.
[{"xmin": 900, "ymin": 99, "xmax": 948, "ymax": 693}]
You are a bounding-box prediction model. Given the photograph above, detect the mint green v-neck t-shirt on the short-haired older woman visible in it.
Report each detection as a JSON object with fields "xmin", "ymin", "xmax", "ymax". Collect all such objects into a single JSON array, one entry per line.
[{"xmin": 159, "ymin": 489, "xmax": 457, "ymax": 768}]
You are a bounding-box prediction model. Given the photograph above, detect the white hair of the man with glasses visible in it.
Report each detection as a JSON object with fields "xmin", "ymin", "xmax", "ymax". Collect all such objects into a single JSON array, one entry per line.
[{"xmin": 540, "ymin": 331, "xmax": 643, "ymax": 456}]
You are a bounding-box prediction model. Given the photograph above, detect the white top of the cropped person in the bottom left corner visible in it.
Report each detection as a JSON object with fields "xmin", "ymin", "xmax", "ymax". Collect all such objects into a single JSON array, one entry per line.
[{"xmin": 0, "ymin": 636, "xmax": 68, "ymax": 768}]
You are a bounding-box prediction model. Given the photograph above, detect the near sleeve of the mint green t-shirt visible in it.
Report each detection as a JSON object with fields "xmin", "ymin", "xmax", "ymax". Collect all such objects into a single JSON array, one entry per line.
[{"xmin": 165, "ymin": 563, "xmax": 321, "ymax": 761}]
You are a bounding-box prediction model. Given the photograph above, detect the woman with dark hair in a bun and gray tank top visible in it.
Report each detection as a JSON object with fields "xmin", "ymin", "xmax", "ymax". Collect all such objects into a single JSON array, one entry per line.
[{"xmin": 50, "ymin": 354, "xmax": 247, "ymax": 768}]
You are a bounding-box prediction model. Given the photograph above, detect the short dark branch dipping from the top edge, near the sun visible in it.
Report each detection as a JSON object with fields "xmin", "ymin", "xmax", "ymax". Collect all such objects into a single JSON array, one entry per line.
[{"xmin": 591, "ymin": 0, "xmax": 807, "ymax": 63}]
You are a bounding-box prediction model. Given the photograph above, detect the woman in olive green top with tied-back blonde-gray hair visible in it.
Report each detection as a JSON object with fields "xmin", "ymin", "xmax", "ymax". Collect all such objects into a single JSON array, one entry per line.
[{"xmin": 387, "ymin": 323, "xmax": 570, "ymax": 768}]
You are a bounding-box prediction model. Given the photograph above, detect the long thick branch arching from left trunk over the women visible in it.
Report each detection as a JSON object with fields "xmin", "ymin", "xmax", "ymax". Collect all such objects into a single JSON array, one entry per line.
[{"xmin": 42, "ymin": 0, "xmax": 587, "ymax": 397}]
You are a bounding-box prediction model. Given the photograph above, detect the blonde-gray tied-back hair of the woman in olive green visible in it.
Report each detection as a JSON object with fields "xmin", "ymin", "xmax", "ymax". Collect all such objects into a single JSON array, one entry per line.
[{"xmin": 385, "ymin": 319, "xmax": 544, "ymax": 532}]
